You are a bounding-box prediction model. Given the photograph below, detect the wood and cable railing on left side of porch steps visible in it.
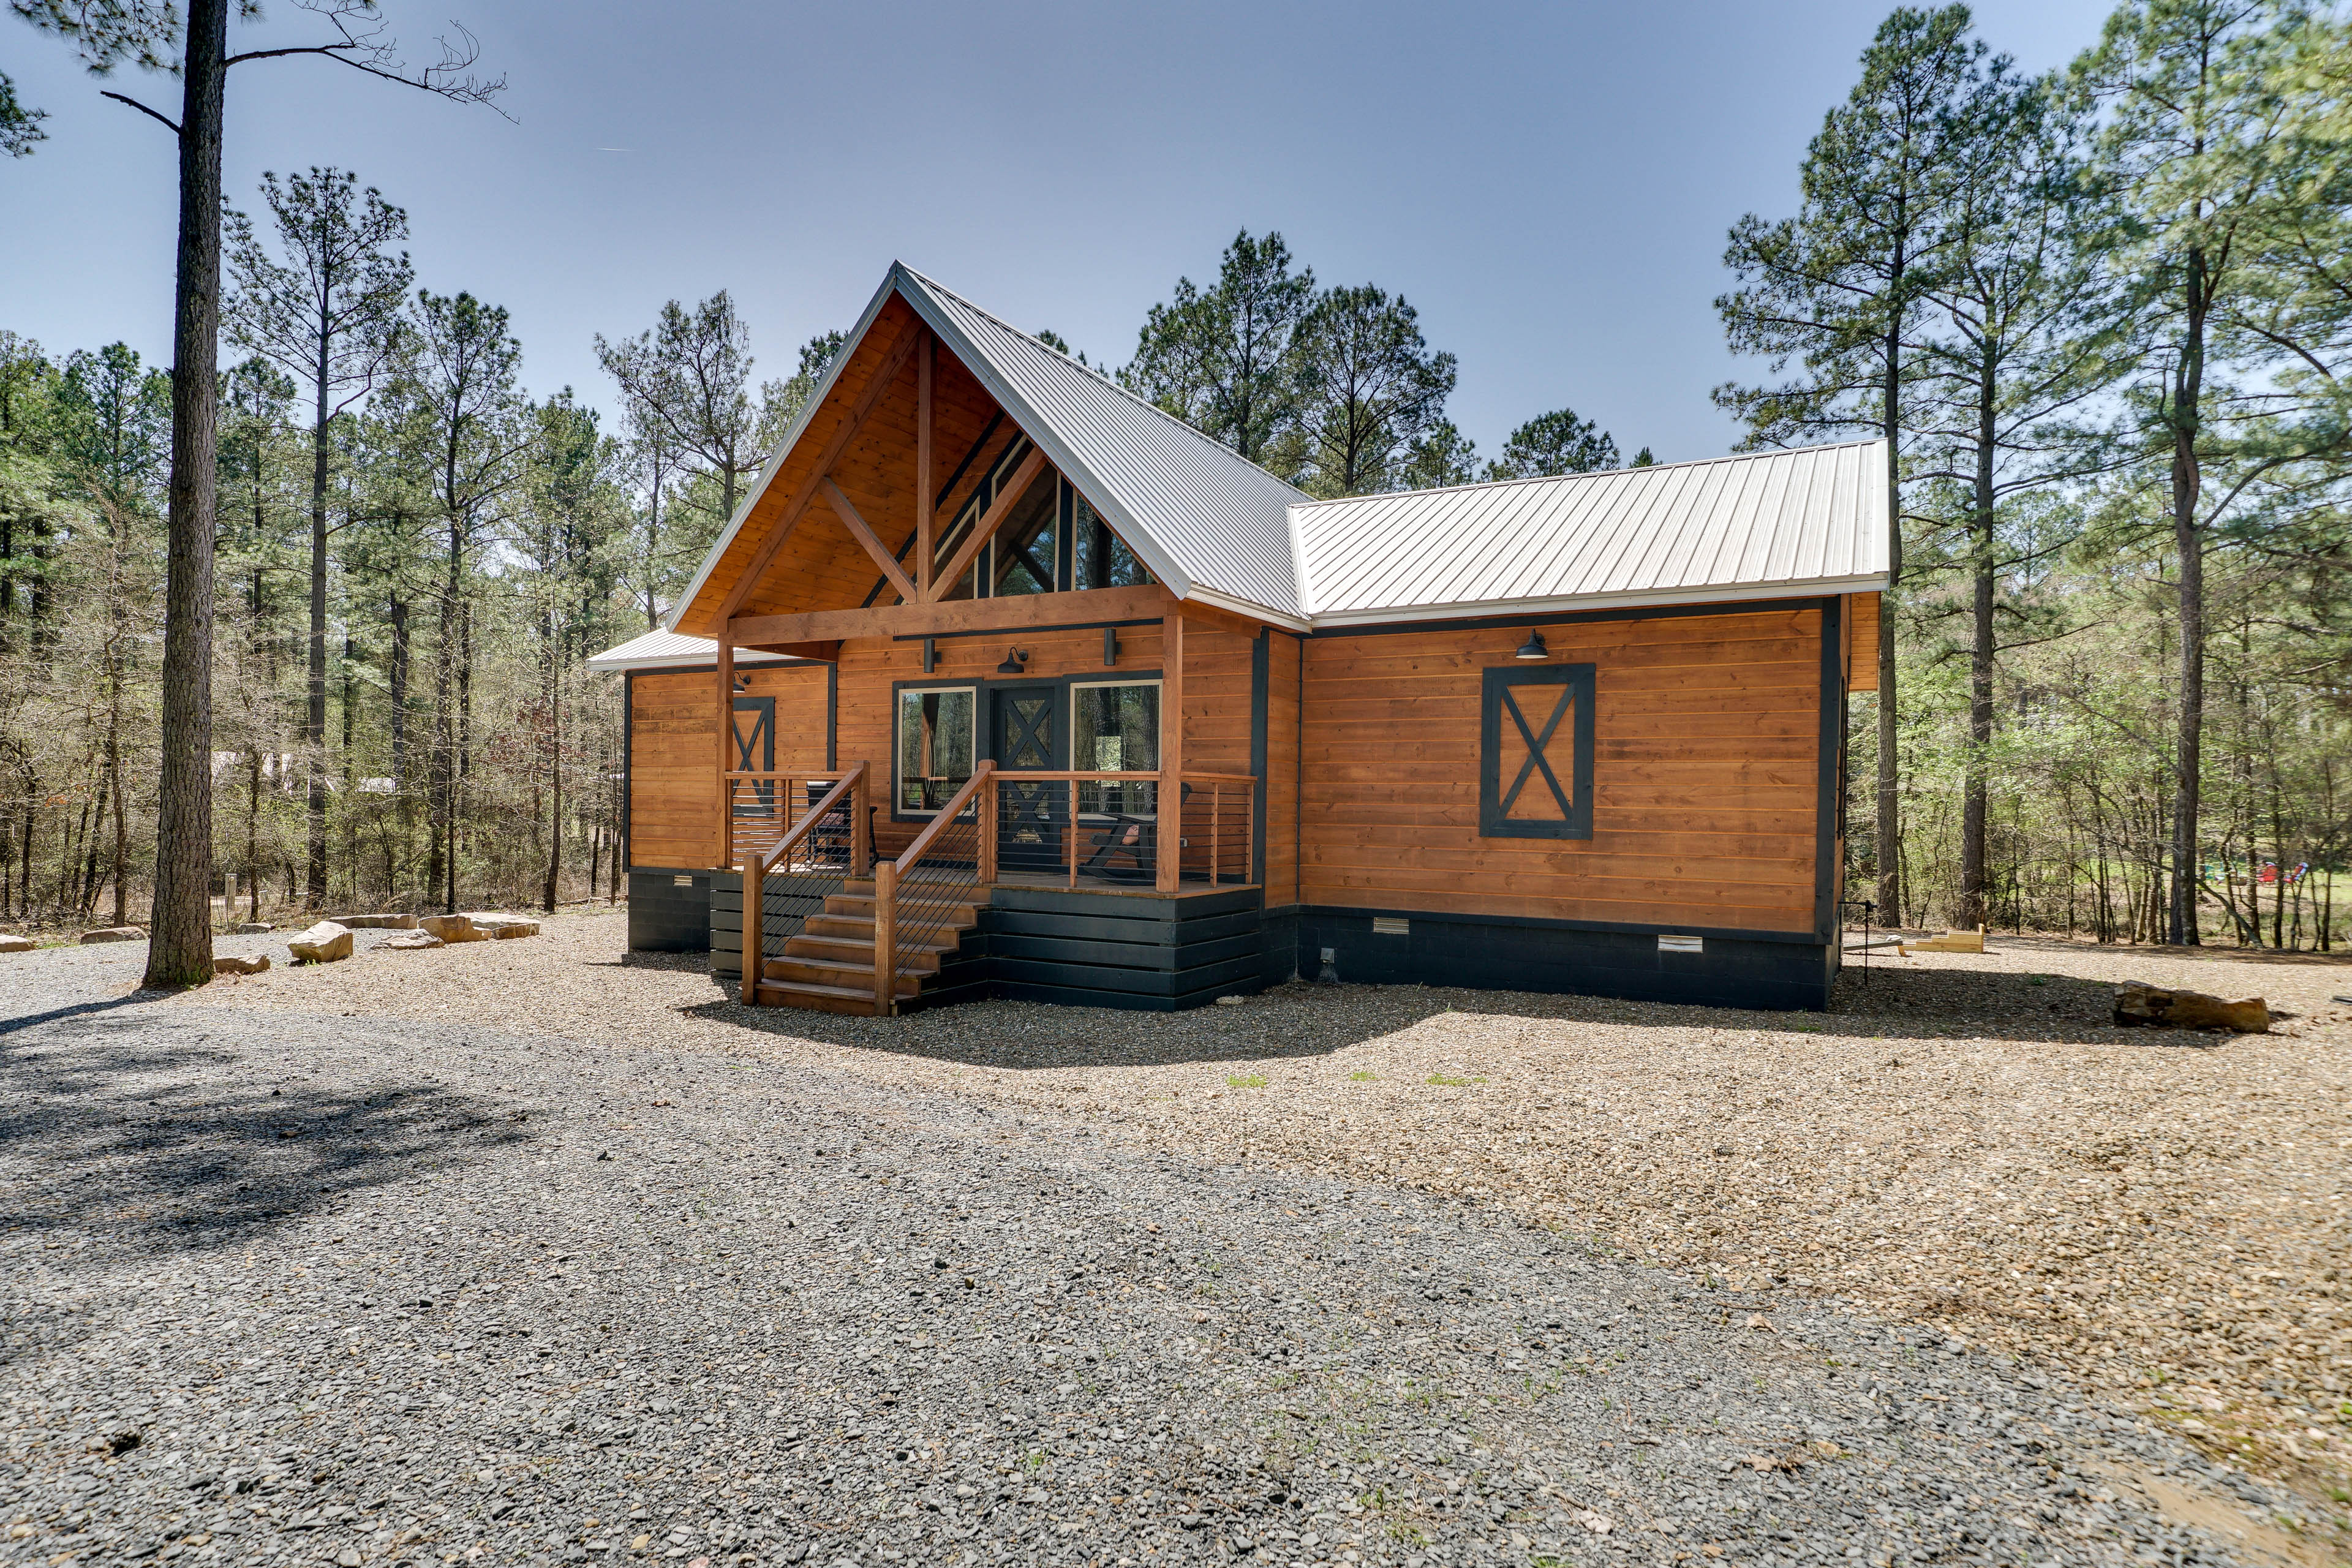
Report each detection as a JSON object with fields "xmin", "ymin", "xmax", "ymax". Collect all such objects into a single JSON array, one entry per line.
[{"xmin": 727, "ymin": 762, "xmax": 870, "ymax": 1004}]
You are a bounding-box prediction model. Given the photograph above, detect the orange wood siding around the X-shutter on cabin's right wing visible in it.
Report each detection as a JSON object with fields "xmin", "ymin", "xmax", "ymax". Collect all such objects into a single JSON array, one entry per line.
[{"xmin": 1298, "ymin": 609, "xmax": 1834, "ymax": 931}]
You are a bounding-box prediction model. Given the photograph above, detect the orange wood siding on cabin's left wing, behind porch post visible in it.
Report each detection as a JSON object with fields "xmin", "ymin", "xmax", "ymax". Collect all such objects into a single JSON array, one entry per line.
[{"xmin": 628, "ymin": 665, "xmax": 826, "ymax": 867}]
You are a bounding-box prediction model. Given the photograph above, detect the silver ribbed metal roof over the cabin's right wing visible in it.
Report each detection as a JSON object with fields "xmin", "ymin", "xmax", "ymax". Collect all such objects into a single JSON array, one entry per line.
[{"xmin": 1291, "ymin": 442, "xmax": 1887, "ymax": 625}]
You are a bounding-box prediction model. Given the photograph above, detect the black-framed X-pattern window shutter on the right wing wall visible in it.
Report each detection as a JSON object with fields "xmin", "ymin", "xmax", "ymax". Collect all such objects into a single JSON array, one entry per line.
[{"xmin": 1477, "ymin": 665, "xmax": 1593, "ymax": 839}]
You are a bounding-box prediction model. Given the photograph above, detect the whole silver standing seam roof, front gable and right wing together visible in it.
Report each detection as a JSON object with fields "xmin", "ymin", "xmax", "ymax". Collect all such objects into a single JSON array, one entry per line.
[{"xmin": 668, "ymin": 261, "xmax": 1887, "ymax": 639}]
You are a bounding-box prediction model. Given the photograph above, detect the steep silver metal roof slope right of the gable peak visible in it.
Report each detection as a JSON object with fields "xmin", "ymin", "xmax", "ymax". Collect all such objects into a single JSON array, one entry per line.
[{"xmin": 891, "ymin": 266, "xmax": 1308, "ymax": 625}]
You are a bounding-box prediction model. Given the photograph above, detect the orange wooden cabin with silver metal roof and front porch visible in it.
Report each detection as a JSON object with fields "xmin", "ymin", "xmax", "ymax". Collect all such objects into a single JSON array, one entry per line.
[{"xmin": 595, "ymin": 266, "xmax": 1887, "ymax": 1013}]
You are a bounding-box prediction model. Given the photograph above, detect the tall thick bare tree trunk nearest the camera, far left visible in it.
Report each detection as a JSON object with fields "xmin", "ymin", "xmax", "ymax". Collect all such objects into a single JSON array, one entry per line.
[{"xmin": 143, "ymin": 0, "xmax": 228, "ymax": 987}]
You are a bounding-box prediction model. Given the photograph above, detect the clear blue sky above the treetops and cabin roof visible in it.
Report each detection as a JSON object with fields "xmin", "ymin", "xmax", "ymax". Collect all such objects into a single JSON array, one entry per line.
[{"xmin": 0, "ymin": 0, "xmax": 2108, "ymax": 461}]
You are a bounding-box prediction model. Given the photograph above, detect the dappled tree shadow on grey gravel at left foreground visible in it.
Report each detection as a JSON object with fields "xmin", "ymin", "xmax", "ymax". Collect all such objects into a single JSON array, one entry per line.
[{"xmin": 0, "ymin": 1018, "xmax": 532, "ymax": 1272}]
